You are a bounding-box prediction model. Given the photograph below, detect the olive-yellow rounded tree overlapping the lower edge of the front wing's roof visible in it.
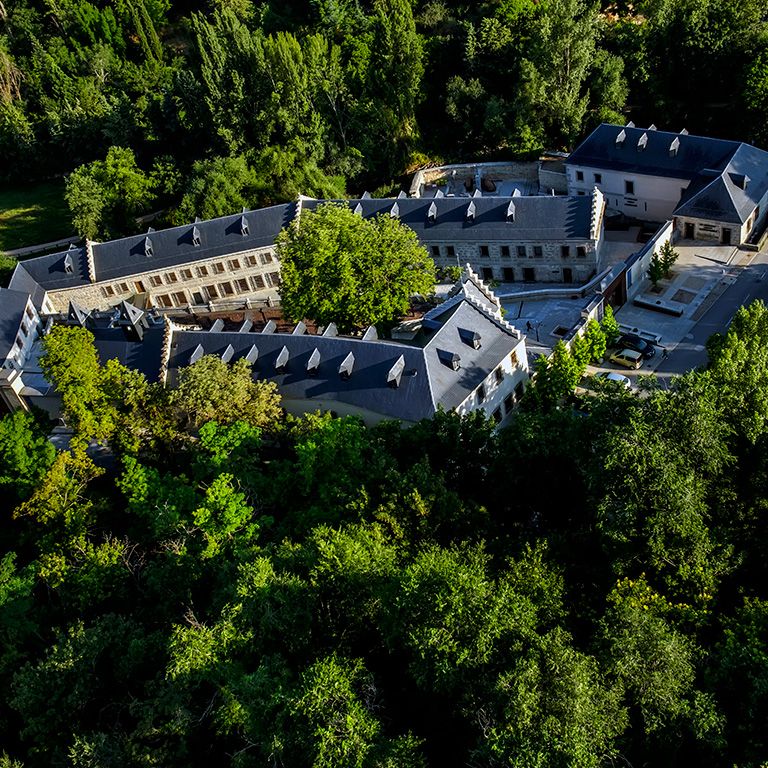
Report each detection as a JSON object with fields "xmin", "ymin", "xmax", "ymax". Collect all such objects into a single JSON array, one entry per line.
[{"xmin": 171, "ymin": 355, "xmax": 282, "ymax": 427}]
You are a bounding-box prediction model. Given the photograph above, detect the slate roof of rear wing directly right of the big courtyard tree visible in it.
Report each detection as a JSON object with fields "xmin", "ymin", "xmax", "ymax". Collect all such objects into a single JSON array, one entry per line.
[{"xmin": 301, "ymin": 195, "xmax": 592, "ymax": 242}]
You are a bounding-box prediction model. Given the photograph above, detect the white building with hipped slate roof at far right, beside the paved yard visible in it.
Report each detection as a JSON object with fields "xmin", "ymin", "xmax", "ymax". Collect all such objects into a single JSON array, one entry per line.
[{"xmin": 566, "ymin": 123, "xmax": 768, "ymax": 245}]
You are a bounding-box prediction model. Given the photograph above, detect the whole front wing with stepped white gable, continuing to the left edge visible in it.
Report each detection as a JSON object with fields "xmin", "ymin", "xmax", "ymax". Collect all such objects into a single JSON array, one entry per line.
[{"xmin": 0, "ymin": 268, "xmax": 528, "ymax": 424}]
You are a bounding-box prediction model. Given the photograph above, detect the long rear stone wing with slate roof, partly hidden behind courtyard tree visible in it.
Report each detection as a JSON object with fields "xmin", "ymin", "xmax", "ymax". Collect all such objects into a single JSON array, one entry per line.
[{"xmin": 10, "ymin": 191, "xmax": 603, "ymax": 320}]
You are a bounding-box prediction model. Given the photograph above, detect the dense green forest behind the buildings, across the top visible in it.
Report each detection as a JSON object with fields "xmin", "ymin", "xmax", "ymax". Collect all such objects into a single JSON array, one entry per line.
[{"xmin": 0, "ymin": 0, "xmax": 768, "ymax": 237}]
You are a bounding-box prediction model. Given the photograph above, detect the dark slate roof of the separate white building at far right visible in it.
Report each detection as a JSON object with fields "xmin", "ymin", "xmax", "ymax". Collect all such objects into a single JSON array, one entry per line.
[{"xmin": 566, "ymin": 123, "xmax": 768, "ymax": 224}]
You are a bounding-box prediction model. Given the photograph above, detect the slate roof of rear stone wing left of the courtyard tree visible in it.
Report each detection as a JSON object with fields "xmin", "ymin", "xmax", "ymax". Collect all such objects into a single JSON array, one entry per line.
[{"xmin": 11, "ymin": 203, "xmax": 296, "ymax": 293}]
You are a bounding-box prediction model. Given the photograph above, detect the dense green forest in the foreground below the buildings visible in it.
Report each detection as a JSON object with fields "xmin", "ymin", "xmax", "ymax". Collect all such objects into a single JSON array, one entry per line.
[{"xmin": 0, "ymin": 302, "xmax": 768, "ymax": 768}]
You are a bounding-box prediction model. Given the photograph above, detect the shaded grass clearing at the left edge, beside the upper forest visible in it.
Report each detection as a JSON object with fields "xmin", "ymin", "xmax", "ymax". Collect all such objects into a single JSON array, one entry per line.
[{"xmin": 0, "ymin": 179, "xmax": 72, "ymax": 253}]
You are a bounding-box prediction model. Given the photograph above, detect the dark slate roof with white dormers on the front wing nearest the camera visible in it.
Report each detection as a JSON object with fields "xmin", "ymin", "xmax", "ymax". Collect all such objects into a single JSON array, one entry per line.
[{"xmin": 168, "ymin": 297, "xmax": 521, "ymax": 422}]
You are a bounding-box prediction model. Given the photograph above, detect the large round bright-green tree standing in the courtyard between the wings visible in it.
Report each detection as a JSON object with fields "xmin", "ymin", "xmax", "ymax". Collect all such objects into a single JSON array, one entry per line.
[{"xmin": 277, "ymin": 203, "xmax": 435, "ymax": 331}]
